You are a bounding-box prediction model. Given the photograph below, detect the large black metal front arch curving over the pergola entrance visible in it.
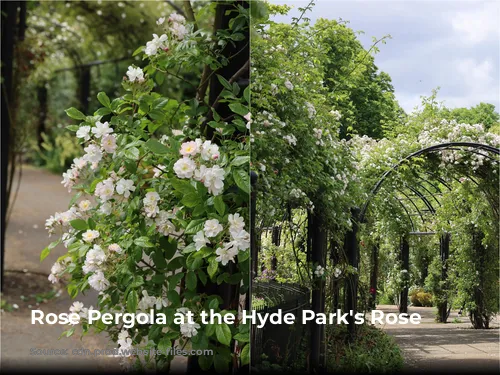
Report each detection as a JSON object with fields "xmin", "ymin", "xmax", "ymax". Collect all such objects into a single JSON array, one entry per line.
[{"xmin": 359, "ymin": 142, "xmax": 500, "ymax": 223}]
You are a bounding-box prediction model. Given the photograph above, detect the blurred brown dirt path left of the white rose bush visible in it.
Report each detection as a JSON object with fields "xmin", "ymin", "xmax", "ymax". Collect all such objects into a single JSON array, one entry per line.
[{"xmin": 1, "ymin": 166, "xmax": 119, "ymax": 372}]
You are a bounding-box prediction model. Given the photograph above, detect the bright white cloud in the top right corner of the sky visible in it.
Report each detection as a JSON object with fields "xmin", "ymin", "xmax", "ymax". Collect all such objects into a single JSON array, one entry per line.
[{"xmin": 451, "ymin": 2, "xmax": 500, "ymax": 44}]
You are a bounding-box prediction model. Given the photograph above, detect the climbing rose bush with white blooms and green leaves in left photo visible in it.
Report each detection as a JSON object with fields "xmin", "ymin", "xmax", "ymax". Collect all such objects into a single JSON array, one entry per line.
[{"xmin": 41, "ymin": 7, "xmax": 250, "ymax": 371}]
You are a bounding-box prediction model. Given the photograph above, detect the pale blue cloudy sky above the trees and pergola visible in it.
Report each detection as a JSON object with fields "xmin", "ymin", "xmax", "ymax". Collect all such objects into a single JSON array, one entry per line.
[{"xmin": 271, "ymin": 0, "xmax": 500, "ymax": 112}]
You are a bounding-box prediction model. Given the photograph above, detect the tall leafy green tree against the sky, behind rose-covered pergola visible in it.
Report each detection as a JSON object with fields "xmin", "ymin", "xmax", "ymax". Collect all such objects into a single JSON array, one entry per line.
[{"xmin": 314, "ymin": 19, "xmax": 403, "ymax": 138}]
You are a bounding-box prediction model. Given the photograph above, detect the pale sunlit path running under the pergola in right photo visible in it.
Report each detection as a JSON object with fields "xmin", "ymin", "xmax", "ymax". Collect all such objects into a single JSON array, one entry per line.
[{"xmin": 377, "ymin": 305, "xmax": 500, "ymax": 373}]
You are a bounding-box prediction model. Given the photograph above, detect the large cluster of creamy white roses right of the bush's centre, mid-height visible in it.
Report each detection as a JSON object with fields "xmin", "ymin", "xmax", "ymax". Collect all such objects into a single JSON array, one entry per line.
[{"xmin": 174, "ymin": 138, "xmax": 225, "ymax": 196}]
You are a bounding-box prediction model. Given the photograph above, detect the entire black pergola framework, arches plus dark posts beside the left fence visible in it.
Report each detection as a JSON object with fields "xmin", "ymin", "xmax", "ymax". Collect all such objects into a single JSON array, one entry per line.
[{"xmin": 251, "ymin": 142, "xmax": 500, "ymax": 369}]
